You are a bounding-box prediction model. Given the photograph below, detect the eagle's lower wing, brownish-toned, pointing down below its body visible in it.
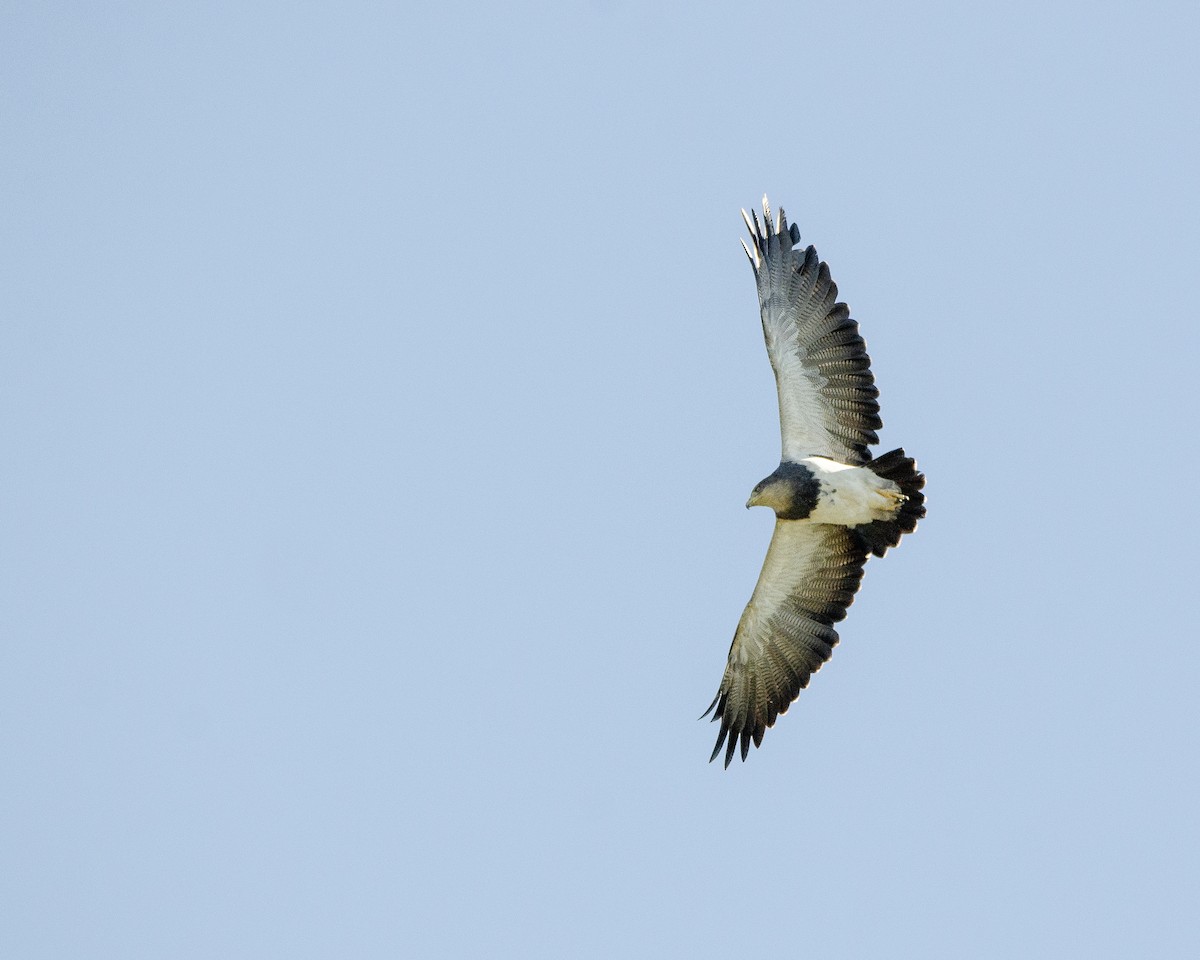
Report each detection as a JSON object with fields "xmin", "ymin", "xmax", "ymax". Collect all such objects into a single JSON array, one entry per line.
[{"xmin": 704, "ymin": 520, "xmax": 866, "ymax": 767}]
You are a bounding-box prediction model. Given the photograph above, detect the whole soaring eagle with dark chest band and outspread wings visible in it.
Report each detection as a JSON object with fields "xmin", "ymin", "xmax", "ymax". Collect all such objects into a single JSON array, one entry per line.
[{"xmin": 704, "ymin": 197, "xmax": 925, "ymax": 767}]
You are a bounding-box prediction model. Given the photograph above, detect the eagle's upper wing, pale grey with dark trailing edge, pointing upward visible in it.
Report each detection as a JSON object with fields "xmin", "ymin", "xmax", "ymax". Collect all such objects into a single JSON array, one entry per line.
[{"xmin": 742, "ymin": 197, "xmax": 883, "ymax": 466}]
